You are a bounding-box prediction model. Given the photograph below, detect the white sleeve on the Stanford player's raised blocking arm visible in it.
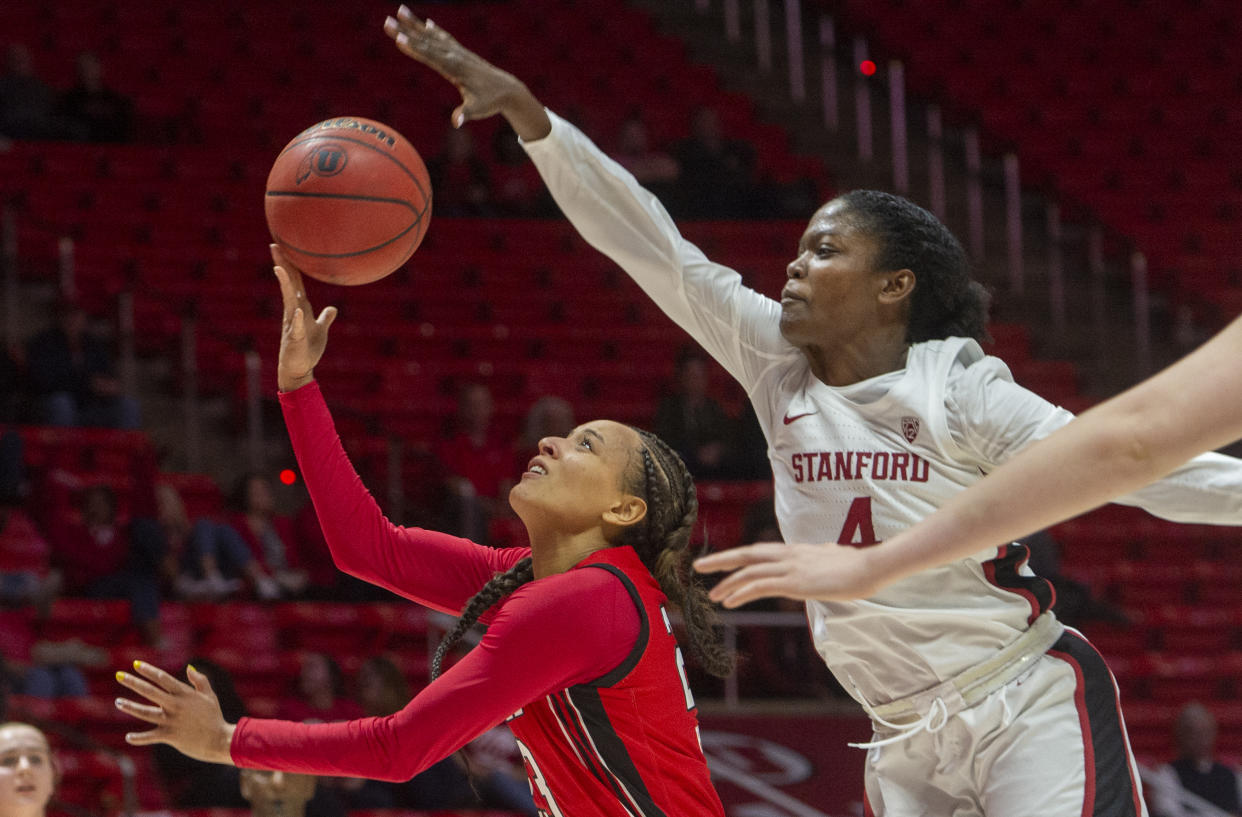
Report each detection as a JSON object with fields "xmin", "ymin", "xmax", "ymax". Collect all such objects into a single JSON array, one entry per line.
[{"xmin": 523, "ymin": 111, "xmax": 794, "ymax": 392}]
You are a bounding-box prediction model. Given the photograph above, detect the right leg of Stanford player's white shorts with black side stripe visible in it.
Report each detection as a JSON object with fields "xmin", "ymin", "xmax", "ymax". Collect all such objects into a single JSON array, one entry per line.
[{"xmin": 971, "ymin": 631, "xmax": 1148, "ymax": 817}]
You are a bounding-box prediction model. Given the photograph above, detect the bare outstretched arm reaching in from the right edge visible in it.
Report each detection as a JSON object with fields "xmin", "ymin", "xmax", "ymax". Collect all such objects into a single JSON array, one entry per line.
[{"xmin": 696, "ymin": 311, "xmax": 1242, "ymax": 607}]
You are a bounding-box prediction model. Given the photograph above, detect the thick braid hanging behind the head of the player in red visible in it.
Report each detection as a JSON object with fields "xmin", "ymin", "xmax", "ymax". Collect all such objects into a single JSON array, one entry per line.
[{"xmin": 621, "ymin": 428, "xmax": 735, "ymax": 678}]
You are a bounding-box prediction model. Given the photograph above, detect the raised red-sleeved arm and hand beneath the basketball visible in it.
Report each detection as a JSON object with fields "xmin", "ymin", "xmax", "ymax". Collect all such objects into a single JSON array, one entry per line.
[{"xmin": 272, "ymin": 246, "xmax": 525, "ymax": 613}]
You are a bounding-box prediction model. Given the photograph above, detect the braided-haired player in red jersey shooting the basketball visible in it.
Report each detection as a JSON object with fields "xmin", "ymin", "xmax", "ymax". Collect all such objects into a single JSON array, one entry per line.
[{"xmin": 117, "ymin": 247, "xmax": 733, "ymax": 817}]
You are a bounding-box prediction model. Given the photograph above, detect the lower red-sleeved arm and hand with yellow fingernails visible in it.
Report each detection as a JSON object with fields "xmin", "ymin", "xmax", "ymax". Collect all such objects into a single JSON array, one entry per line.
[{"xmin": 116, "ymin": 570, "xmax": 641, "ymax": 781}]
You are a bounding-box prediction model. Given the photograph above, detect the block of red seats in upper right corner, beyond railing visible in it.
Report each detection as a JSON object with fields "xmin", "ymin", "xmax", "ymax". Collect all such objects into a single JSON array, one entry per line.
[{"xmin": 820, "ymin": 0, "xmax": 1242, "ymax": 320}]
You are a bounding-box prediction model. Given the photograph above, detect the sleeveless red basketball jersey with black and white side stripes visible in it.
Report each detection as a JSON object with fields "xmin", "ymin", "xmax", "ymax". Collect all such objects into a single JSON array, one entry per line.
[{"xmin": 508, "ymin": 548, "xmax": 724, "ymax": 817}]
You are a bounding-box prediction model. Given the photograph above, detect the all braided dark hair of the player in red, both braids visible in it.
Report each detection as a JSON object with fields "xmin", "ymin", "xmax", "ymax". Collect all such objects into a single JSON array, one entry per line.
[{"xmin": 431, "ymin": 428, "xmax": 734, "ymax": 680}]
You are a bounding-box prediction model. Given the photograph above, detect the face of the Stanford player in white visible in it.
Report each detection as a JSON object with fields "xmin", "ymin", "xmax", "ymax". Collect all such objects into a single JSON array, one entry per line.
[{"xmin": 780, "ymin": 200, "xmax": 883, "ymax": 350}]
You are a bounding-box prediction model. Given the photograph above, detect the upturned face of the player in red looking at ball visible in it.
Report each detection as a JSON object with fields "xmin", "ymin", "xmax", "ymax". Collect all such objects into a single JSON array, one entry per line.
[{"xmin": 509, "ymin": 420, "xmax": 641, "ymax": 534}]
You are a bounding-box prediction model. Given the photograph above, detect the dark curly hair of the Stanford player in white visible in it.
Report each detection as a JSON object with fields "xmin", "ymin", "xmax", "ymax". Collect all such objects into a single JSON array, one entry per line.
[{"xmin": 836, "ymin": 190, "xmax": 990, "ymax": 343}]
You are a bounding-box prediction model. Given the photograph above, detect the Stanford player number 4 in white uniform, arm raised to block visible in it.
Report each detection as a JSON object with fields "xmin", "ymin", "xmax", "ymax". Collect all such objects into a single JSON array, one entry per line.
[{"xmin": 386, "ymin": 7, "xmax": 1242, "ymax": 817}]
